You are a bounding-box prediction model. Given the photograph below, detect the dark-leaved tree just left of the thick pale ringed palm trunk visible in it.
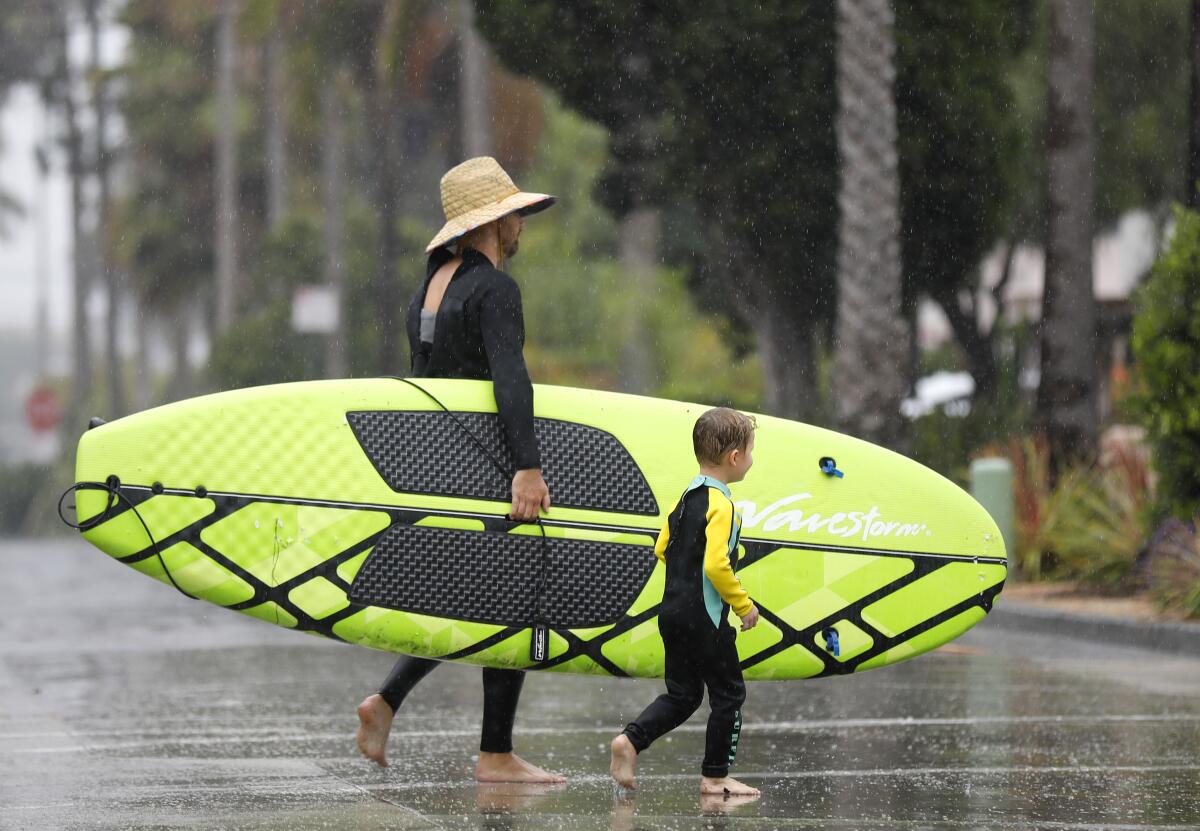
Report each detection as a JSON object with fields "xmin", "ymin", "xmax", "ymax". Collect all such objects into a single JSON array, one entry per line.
[{"xmin": 479, "ymin": 0, "xmax": 836, "ymax": 417}]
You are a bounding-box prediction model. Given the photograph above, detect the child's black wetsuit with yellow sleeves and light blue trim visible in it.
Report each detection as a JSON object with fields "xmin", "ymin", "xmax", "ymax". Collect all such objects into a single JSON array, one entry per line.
[{"xmin": 624, "ymin": 476, "xmax": 752, "ymax": 777}]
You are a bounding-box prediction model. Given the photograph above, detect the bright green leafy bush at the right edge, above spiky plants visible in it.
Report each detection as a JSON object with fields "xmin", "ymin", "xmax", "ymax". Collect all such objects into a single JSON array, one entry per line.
[{"xmin": 1132, "ymin": 207, "xmax": 1200, "ymax": 520}]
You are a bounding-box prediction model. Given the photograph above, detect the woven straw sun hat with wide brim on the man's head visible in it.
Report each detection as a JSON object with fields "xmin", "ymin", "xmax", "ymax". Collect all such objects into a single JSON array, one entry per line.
[{"xmin": 425, "ymin": 156, "xmax": 554, "ymax": 253}]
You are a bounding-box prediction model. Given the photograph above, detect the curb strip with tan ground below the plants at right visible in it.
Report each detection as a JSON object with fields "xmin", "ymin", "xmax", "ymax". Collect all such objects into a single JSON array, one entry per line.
[{"xmin": 988, "ymin": 581, "xmax": 1200, "ymax": 656}]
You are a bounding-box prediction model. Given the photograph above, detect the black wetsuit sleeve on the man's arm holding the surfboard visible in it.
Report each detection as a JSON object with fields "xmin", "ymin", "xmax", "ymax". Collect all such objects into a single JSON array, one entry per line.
[{"xmin": 480, "ymin": 274, "xmax": 541, "ymax": 471}]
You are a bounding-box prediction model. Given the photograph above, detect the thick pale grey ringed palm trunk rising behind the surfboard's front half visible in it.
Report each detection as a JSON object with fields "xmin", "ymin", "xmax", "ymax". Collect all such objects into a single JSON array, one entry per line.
[{"xmin": 833, "ymin": 0, "xmax": 908, "ymax": 449}]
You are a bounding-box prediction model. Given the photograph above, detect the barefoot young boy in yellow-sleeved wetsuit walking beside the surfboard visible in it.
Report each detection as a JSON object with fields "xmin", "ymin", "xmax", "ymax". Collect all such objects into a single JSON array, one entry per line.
[{"xmin": 610, "ymin": 407, "xmax": 758, "ymax": 796}]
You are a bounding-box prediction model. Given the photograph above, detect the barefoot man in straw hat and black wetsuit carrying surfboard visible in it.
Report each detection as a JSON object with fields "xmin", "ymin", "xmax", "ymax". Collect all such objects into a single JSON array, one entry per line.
[{"xmin": 358, "ymin": 156, "xmax": 563, "ymax": 782}]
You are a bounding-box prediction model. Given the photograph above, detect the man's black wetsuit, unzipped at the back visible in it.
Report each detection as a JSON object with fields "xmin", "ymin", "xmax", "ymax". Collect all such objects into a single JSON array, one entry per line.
[{"xmin": 379, "ymin": 249, "xmax": 541, "ymax": 753}]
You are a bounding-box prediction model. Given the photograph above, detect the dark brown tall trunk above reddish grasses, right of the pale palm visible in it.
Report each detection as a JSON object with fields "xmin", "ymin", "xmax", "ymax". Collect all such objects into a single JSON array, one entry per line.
[{"xmin": 1037, "ymin": 0, "xmax": 1099, "ymax": 468}]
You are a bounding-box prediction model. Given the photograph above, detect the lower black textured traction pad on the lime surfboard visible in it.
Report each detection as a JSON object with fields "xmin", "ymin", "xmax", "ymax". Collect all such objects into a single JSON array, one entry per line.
[{"xmin": 348, "ymin": 525, "xmax": 655, "ymax": 628}]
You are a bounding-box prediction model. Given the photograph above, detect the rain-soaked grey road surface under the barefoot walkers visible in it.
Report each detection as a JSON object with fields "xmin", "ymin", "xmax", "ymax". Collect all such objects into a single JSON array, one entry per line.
[{"xmin": 0, "ymin": 539, "xmax": 1200, "ymax": 831}]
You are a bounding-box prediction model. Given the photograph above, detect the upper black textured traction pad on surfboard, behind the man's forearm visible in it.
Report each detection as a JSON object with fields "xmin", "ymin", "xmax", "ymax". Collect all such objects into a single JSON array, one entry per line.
[{"xmin": 346, "ymin": 409, "xmax": 659, "ymax": 516}]
